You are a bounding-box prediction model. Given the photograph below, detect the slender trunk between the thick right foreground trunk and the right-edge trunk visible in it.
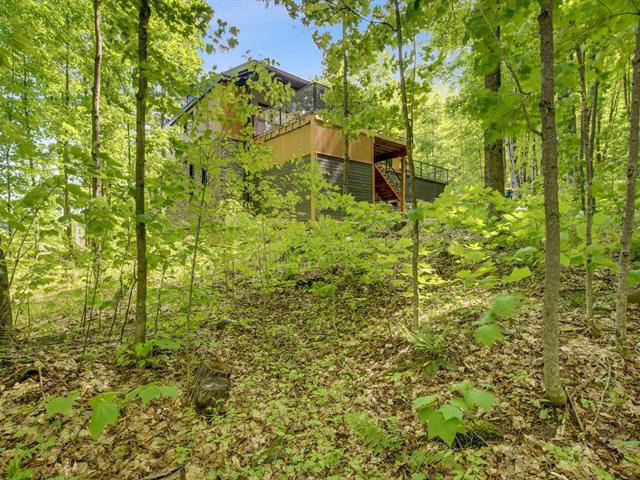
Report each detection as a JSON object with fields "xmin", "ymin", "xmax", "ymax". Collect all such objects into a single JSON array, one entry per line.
[{"xmin": 585, "ymin": 82, "xmax": 598, "ymax": 328}]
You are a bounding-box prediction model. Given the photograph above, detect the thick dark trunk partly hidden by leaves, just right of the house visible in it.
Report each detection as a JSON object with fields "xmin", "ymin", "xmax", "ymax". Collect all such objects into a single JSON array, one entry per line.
[{"xmin": 484, "ymin": 27, "xmax": 505, "ymax": 195}]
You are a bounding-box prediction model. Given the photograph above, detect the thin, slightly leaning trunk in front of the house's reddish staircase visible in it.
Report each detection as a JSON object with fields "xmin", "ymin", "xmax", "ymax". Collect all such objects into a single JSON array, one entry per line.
[{"xmin": 393, "ymin": 0, "xmax": 420, "ymax": 326}]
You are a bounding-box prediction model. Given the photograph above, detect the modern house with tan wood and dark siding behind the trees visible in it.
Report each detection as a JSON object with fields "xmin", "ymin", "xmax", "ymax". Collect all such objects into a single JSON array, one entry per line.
[{"xmin": 170, "ymin": 62, "xmax": 449, "ymax": 218}]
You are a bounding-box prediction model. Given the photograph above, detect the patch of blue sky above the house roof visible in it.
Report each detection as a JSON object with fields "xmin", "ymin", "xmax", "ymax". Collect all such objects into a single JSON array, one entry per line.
[{"xmin": 202, "ymin": 0, "xmax": 338, "ymax": 79}]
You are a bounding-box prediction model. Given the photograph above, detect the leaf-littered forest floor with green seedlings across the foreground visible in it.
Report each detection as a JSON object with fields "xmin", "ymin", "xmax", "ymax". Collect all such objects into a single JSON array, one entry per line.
[{"xmin": 0, "ymin": 273, "xmax": 640, "ymax": 479}]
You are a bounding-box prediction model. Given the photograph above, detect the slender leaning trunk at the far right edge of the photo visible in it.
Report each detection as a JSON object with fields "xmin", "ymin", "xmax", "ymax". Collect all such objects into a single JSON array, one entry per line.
[{"xmin": 616, "ymin": 20, "xmax": 640, "ymax": 354}]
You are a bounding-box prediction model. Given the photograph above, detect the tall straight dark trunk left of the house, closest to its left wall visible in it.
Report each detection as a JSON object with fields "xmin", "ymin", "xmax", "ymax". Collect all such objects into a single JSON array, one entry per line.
[{"xmin": 135, "ymin": 0, "xmax": 151, "ymax": 342}]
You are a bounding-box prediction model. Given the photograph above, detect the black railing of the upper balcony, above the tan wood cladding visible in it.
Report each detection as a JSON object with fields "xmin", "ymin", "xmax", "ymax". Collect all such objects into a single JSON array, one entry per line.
[{"xmin": 253, "ymin": 82, "xmax": 327, "ymax": 135}]
